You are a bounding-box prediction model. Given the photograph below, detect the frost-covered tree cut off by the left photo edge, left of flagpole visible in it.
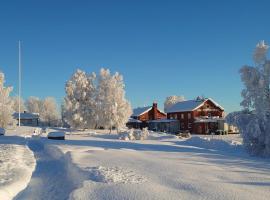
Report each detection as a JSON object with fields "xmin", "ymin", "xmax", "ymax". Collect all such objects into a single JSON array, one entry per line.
[{"xmin": 0, "ymin": 72, "xmax": 14, "ymax": 128}]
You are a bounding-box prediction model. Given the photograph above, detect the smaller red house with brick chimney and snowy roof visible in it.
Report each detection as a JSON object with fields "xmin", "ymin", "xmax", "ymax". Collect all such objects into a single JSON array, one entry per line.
[{"xmin": 127, "ymin": 102, "xmax": 167, "ymax": 128}]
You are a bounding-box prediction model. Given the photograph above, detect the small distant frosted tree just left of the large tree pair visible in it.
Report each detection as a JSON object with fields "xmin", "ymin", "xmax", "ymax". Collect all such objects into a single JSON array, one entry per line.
[{"xmin": 40, "ymin": 97, "xmax": 60, "ymax": 126}]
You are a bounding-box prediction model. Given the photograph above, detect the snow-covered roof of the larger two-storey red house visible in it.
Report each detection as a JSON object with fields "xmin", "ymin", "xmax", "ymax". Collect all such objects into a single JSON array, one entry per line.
[{"xmin": 167, "ymin": 98, "xmax": 224, "ymax": 113}]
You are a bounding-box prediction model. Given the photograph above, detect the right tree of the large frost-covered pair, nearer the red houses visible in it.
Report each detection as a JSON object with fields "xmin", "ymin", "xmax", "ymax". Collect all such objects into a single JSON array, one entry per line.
[{"xmin": 96, "ymin": 68, "xmax": 132, "ymax": 129}]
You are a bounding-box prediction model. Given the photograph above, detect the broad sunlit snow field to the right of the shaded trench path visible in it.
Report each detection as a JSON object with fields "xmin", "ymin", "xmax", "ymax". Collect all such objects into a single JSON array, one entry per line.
[{"xmin": 58, "ymin": 134, "xmax": 270, "ymax": 199}]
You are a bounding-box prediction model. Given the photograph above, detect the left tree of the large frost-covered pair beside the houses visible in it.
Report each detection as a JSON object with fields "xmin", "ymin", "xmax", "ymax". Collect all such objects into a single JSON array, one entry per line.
[{"xmin": 63, "ymin": 70, "xmax": 96, "ymax": 129}]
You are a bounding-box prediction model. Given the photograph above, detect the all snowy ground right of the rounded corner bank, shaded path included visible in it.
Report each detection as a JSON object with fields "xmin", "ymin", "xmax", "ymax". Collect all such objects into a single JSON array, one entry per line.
[{"xmin": 0, "ymin": 127, "xmax": 270, "ymax": 200}]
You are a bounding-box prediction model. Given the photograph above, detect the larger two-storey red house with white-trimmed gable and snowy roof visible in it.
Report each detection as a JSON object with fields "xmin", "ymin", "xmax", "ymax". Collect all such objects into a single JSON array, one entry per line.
[{"xmin": 167, "ymin": 98, "xmax": 224, "ymax": 134}]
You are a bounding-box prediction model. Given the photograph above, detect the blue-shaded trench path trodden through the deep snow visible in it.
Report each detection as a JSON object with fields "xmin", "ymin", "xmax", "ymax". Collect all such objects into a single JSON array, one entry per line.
[{"xmin": 15, "ymin": 140, "xmax": 85, "ymax": 200}]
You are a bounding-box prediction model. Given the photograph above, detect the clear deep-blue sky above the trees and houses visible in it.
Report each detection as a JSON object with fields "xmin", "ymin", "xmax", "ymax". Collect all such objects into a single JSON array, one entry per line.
[{"xmin": 0, "ymin": 0, "xmax": 270, "ymax": 112}]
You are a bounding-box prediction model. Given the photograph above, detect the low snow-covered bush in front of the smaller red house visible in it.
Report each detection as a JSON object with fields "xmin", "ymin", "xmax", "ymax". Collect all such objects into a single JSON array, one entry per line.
[{"xmin": 119, "ymin": 128, "xmax": 149, "ymax": 140}]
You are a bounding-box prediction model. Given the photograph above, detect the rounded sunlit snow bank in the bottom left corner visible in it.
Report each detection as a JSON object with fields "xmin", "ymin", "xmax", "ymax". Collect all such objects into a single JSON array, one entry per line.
[{"xmin": 0, "ymin": 144, "xmax": 36, "ymax": 200}]
